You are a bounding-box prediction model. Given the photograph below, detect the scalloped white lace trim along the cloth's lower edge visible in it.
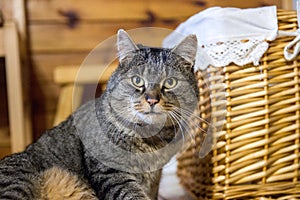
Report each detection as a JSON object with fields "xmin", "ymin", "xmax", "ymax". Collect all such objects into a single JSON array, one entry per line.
[{"xmin": 196, "ymin": 37, "xmax": 269, "ymax": 69}]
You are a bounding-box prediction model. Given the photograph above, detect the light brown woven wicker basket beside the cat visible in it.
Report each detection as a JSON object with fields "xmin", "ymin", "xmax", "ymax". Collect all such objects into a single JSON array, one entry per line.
[{"xmin": 178, "ymin": 10, "xmax": 300, "ymax": 199}]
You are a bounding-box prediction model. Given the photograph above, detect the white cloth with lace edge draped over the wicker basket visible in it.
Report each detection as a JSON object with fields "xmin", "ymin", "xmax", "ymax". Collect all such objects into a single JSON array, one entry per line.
[{"xmin": 163, "ymin": 6, "xmax": 278, "ymax": 70}]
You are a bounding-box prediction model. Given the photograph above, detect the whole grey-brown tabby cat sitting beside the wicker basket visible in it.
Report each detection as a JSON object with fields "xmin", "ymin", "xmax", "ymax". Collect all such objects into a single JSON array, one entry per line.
[{"xmin": 0, "ymin": 30, "xmax": 199, "ymax": 200}]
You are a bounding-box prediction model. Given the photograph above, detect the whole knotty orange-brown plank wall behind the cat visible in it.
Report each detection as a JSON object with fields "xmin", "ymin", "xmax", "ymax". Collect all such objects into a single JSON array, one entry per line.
[{"xmin": 27, "ymin": 0, "xmax": 281, "ymax": 137}]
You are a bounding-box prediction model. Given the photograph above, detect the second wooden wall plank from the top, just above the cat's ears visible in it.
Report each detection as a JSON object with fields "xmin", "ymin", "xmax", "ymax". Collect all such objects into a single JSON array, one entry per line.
[{"xmin": 30, "ymin": 22, "xmax": 176, "ymax": 53}]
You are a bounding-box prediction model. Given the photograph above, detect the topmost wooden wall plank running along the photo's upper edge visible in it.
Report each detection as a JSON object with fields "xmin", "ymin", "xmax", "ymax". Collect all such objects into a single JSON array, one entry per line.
[{"xmin": 28, "ymin": 0, "xmax": 281, "ymax": 22}]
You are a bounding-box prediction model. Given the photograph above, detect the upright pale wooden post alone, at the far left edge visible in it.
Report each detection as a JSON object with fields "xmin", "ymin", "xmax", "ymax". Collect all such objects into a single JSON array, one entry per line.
[{"xmin": 4, "ymin": 22, "xmax": 31, "ymax": 152}]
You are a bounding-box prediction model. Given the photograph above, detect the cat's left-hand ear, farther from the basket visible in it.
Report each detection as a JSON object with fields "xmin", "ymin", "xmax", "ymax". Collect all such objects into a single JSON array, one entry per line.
[{"xmin": 117, "ymin": 29, "xmax": 139, "ymax": 62}]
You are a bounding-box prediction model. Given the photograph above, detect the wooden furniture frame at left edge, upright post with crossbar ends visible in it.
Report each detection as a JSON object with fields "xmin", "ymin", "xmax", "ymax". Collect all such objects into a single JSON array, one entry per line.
[{"xmin": 0, "ymin": 21, "xmax": 32, "ymax": 153}]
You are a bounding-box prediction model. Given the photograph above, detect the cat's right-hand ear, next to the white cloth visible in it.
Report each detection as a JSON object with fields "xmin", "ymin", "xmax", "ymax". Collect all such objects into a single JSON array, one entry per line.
[{"xmin": 172, "ymin": 35, "xmax": 198, "ymax": 65}]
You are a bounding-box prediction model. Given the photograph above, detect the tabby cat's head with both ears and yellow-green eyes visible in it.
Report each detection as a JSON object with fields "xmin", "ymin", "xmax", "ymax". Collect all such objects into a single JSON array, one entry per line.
[{"xmin": 107, "ymin": 30, "xmax": 198, "ymax": 138}]
